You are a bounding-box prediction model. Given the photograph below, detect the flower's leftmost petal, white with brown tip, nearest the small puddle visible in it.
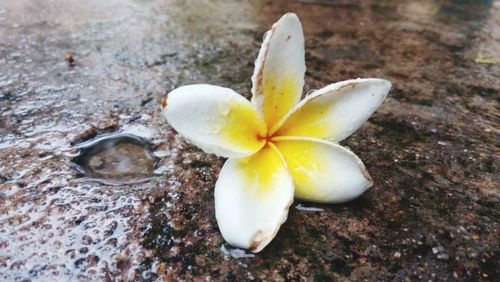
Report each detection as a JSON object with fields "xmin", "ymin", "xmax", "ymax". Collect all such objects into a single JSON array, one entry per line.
[{"xmin": 162, "ymin": 84, "xmax": 266, "ymax": 157}]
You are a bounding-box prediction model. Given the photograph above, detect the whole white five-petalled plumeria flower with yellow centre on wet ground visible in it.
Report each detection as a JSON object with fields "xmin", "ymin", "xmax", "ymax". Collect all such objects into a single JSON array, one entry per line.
[{"xmin": 162, "ymin": 13, "xmax": 391, "ymax": 252}]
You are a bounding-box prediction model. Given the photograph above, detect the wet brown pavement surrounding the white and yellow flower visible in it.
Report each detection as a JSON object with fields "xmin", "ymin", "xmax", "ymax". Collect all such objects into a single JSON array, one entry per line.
[{"xmin": 0, "ymin": 0, "xmax": 500, "ymax": 281}]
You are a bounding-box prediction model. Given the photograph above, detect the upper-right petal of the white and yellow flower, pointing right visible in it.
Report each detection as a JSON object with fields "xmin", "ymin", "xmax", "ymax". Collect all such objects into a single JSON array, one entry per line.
[{"xmin": 272, "ymin": 78, "xmax": 391, "ymax": 142}]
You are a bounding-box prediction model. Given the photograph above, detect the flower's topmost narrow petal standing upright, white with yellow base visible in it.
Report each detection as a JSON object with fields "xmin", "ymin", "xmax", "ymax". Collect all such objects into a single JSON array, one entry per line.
[{"xmin": 252, "ymin": 13, "xmax": 306, "ymax": 128}]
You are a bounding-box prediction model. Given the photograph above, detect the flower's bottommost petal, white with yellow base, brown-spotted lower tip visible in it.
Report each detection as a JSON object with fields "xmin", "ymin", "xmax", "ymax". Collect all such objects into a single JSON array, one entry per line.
[{"xmin": 215, "ymin": 146, "xmax": 293, "ymax": 252}]
